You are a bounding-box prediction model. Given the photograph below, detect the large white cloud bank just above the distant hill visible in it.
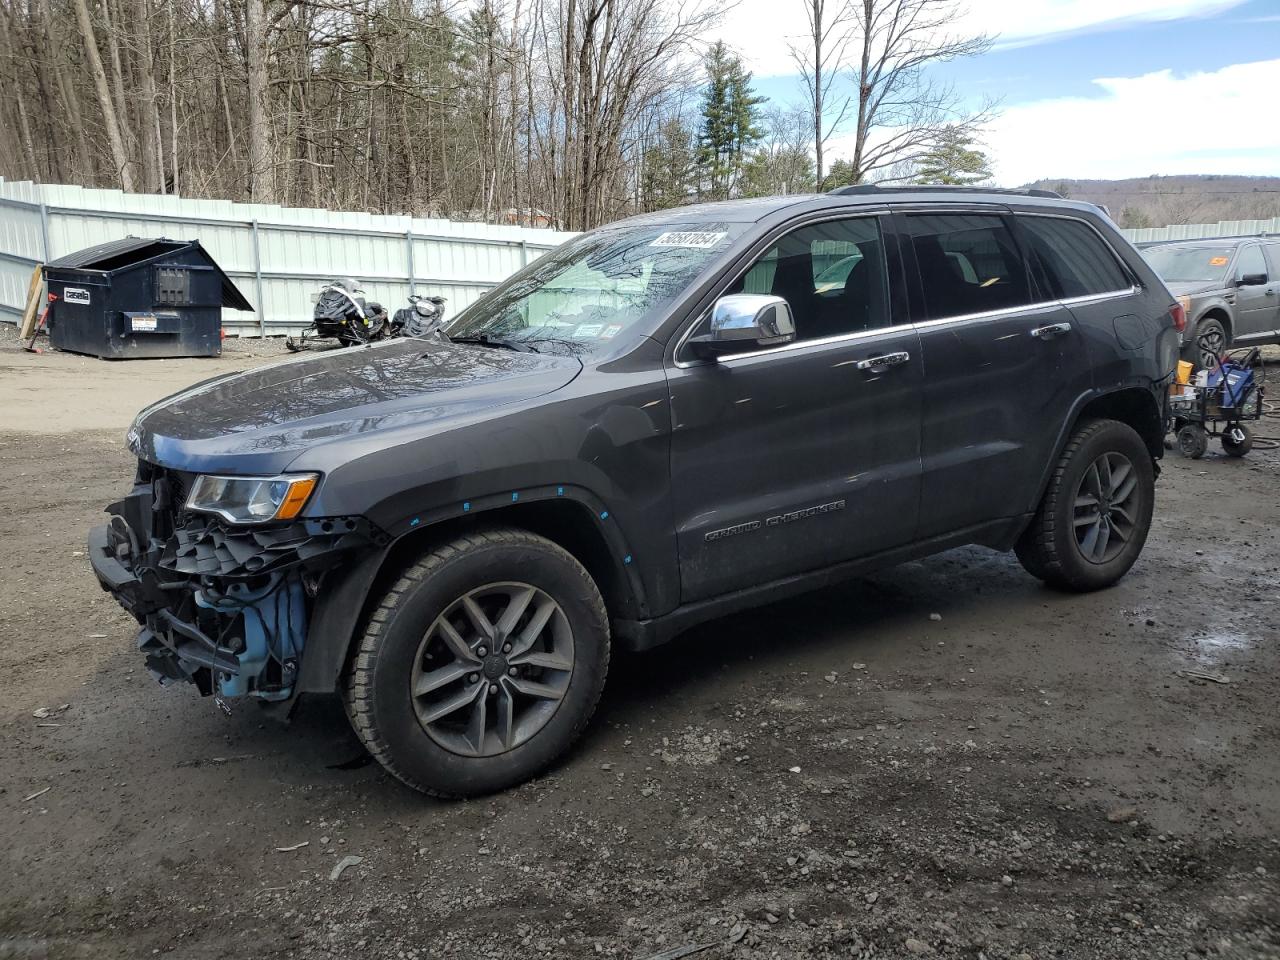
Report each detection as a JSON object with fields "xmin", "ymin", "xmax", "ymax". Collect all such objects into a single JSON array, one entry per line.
[{"xmin": 977, "ymin": 60, "xmax": 1280, "ymax": 186}]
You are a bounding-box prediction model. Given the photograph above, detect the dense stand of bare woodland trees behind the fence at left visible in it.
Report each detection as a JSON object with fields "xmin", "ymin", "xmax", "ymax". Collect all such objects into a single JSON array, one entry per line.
[{"xmin": 0, "ymin": 0, "xmax": 716, "ymax": 228}]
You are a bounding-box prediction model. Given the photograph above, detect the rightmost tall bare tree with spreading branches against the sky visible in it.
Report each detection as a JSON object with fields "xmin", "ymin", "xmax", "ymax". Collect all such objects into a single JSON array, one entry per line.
[{"xmin": 850, "ymin": 0, "xmax": 996, "ymax": 183}]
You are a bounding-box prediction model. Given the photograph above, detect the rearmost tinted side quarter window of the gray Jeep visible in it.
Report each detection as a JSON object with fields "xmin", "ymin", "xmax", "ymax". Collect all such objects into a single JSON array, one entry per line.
[{"xmin": 1018, "ymin": 215, "xmax": 1133, "ymax": 300}]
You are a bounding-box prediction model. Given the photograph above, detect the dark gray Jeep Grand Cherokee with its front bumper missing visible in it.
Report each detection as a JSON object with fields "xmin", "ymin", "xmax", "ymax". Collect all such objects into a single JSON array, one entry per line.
[{"xmin": 90, "ymin": 187, "xmax": 1181, "ymax": 796}]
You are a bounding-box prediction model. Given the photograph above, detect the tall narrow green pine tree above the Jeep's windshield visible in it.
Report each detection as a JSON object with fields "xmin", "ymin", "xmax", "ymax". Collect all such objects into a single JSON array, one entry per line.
[{"xmin": 698, "ymin": 41, "xmax": 764, "ymax": 200}]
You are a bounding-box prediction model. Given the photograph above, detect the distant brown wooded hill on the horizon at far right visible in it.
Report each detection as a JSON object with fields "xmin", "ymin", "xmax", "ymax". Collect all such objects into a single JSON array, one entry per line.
[{"xmin": 1027, "ymin": 175, "xmax": 1280, "ymax": 227}]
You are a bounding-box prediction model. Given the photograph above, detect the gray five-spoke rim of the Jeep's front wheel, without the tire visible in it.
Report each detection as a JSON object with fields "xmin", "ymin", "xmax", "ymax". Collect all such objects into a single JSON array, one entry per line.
[{"xmin": 410, "ymin": 582, "xmax": 573, "ymax": 756}]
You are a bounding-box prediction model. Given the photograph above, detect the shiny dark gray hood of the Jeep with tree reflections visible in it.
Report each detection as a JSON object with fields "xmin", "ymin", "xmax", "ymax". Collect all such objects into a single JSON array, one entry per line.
[{"xmin": 128, "ymin": 338, "xmax": 582, "ymax": 472}]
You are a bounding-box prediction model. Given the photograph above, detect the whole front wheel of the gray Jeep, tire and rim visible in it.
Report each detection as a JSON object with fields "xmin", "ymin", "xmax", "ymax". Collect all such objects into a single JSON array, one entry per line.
[{"xmin": 344, "ymin": 529, "xmax": 609, "ymax": 797}]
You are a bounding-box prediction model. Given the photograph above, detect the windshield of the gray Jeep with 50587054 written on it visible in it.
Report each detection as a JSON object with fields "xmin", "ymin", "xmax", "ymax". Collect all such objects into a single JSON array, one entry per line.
[{"xmin": 444, "ymin": 223, "xmax": 749, "ymax": 353}]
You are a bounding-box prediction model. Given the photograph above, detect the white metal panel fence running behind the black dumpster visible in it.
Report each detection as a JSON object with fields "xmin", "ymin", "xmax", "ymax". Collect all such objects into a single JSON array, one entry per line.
[{"xmin": 0, "ymin": 178, "xmax": 573, "ymax": 334}]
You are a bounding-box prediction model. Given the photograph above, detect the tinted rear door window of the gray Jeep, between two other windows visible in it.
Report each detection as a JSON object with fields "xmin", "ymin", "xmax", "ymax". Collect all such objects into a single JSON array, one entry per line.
[{"xmin": 904, "ymin": 214, "xmax": 1032, "ymax": 320}]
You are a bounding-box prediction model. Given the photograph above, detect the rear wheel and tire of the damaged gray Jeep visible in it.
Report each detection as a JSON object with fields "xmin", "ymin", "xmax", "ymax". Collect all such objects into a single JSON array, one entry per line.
[{"xmin": 1014, "ymin": 420, "xmax": 1156, "ymax": 593}]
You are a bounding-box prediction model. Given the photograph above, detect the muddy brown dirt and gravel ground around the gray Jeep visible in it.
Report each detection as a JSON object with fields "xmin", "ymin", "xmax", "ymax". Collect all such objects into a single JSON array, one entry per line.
[{"xmin": 0, "ymin": 325, "xmax": 1280, "ymax": 960}]
